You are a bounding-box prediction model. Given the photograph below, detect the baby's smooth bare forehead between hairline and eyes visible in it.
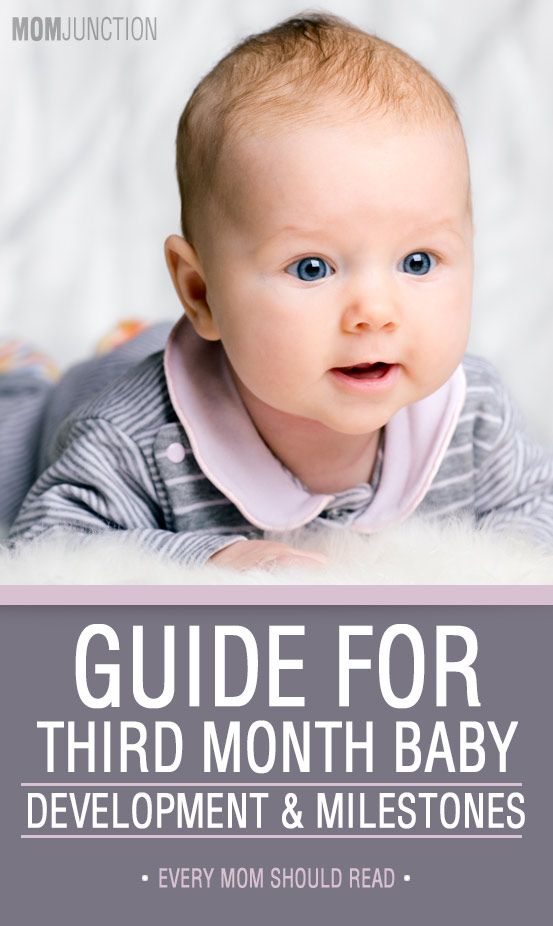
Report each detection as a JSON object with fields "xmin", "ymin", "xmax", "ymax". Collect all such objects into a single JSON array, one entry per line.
[{"xmin": 196, "ymin": 113, "xmax": 470, "ymax": 260}]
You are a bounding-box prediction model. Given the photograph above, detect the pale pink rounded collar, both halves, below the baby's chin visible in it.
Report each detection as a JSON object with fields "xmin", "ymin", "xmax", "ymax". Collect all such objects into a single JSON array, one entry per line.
[{"xmin": 165, "ymin": 317, "xmax": 466, "ymax": 533}]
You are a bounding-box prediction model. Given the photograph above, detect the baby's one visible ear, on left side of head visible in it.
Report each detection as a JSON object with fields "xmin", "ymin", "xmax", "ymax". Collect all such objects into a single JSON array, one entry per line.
[{"xmin": 165, "ymin": 235, "xmax": 220, "ymax": 341}]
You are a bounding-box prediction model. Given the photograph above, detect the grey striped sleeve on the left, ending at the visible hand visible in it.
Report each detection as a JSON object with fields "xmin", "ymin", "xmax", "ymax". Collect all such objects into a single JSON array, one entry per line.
[{"xmin": 9, "ymin": 418, "xmax": 246, "ymax": 565}]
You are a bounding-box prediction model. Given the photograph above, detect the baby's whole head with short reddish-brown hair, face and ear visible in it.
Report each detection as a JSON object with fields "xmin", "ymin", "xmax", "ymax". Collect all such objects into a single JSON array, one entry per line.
[{"xmin": 167, "ymin": 15, "xmax": 472, "ymax": 434}]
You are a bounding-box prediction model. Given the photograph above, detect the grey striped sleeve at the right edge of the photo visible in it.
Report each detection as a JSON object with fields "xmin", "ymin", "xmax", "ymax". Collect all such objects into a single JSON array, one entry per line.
[{"xmin": 473, "ymin": 368, "xmax": 553, "ymax": 548}]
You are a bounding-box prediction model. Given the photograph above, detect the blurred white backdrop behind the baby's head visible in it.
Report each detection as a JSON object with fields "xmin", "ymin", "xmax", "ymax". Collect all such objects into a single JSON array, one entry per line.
[{"xmin": 0, "ymin": 0, "xmax": 553, "ymax": 445}]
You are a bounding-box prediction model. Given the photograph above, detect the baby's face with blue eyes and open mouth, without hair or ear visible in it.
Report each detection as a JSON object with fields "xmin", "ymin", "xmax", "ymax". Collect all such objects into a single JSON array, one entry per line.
[{"xmin": 193, "ymin": 110, "xmax": 472, "ymax": 434}]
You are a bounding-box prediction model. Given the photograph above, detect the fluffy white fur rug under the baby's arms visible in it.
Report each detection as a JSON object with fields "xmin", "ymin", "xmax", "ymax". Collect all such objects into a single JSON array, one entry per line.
[{"xmin": 0, "ymin": 519, "xmax": 553, "ymax": 585}]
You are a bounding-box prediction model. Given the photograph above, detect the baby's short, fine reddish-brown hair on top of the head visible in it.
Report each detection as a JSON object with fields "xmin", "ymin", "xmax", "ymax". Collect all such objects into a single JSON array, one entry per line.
[{"xmin": 177, "ymin": 13, "xmax": 461, "ymax": 238}]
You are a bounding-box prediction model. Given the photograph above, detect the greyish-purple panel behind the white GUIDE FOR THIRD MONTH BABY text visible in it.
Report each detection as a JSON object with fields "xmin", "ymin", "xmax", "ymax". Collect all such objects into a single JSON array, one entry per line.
[{"xmin": 0, "ymin": 606, "xmax": 553, "ymax": 926}]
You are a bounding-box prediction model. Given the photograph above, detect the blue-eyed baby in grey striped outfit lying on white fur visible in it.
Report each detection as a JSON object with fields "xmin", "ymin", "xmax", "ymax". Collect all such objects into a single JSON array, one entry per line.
[{"xmin": 3, "ymin": 15, "xmax": 553, "ymax": 569}]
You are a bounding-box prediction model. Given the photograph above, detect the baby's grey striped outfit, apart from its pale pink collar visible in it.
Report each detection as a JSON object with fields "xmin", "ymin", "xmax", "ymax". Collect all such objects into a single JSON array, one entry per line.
[{"xmin": 0, "ymin": 326, "xmax": 553, "ymax": 564}]
